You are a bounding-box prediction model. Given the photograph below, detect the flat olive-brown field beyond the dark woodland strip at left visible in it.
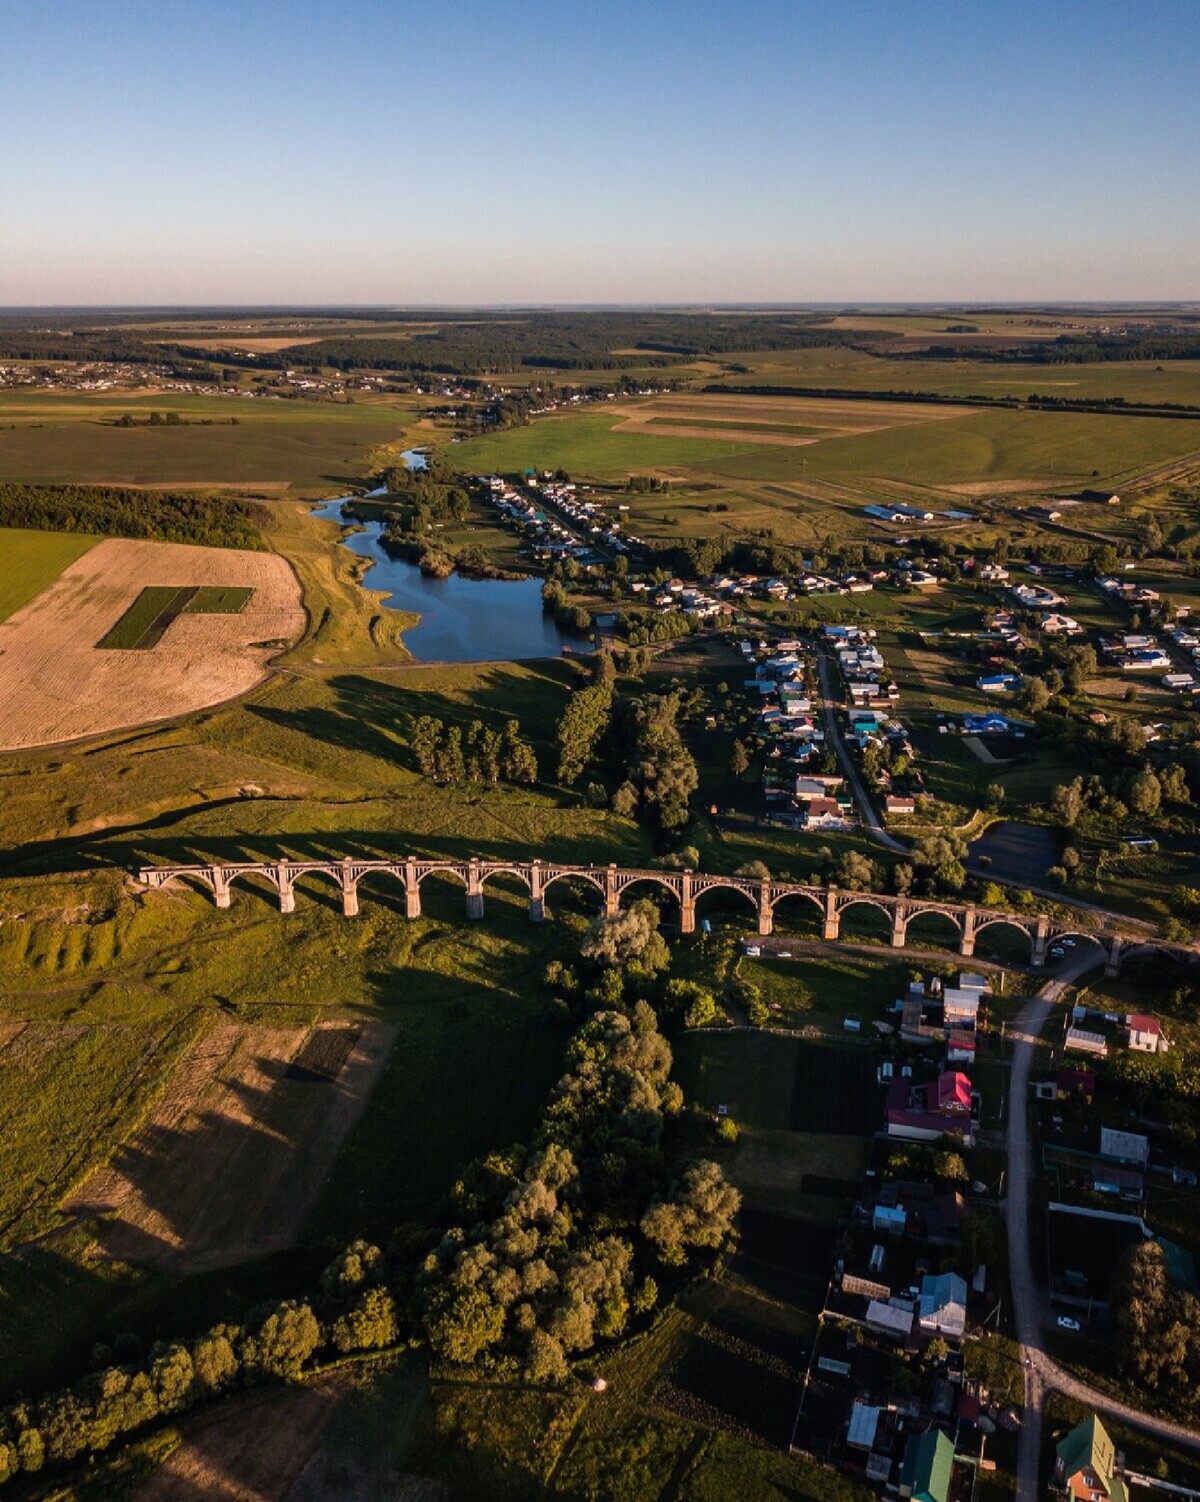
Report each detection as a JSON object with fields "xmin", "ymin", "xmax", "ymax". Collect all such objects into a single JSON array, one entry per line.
[{"xmin": 0, "ymin": 391, "xmax": 410, "ymax": 494}]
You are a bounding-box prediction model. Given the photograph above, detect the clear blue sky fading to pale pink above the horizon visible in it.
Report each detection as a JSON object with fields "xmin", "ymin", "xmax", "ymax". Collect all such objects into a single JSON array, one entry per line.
[{"xmin": 0, "ymin": 0, "xmax": 1200, "ymax": 306}]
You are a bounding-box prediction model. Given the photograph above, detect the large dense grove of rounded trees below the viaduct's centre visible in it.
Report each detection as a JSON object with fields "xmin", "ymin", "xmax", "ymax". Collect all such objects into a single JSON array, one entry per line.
[{"xmin": 419, "ymin": 1002, "xmax": 739, "ymax": 1382}]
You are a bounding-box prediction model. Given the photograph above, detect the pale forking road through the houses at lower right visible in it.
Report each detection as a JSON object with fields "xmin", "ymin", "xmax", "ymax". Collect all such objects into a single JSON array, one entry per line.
[{"xmin": 1005, "ymin": 946, "xmax": 1200, "ymax": 1502}]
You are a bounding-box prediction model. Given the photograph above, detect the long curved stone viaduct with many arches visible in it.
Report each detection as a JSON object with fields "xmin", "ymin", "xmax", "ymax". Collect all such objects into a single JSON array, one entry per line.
[{"xmin": 137, "ymin": 856, "xmax": 1177, "ymax": 975}]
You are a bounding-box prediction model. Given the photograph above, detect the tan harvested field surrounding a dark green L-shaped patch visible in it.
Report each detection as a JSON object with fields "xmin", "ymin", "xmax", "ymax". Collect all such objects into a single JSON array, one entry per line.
[{"xmin": 0, "ymin": 538, "xmax": 305, "ymax": 751}]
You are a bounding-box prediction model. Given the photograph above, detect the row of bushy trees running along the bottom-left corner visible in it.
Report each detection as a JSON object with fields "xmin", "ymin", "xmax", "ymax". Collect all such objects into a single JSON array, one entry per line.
[{"xmin": 0, "ymin": 1242, "xmax": 399, "ymax": 1482}]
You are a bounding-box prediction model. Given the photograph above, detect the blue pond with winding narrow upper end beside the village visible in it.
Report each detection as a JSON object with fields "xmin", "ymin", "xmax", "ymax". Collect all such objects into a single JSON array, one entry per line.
[{"xmin": 314, "ymin": 500, "xmax": 590, "ymax": 662}]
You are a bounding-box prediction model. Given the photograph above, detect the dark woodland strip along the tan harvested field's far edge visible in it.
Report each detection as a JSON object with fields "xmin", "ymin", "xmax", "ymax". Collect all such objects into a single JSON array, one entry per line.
[{"xmin": 0, "ymin": 481, "xmax": 263, "ymax": 551}]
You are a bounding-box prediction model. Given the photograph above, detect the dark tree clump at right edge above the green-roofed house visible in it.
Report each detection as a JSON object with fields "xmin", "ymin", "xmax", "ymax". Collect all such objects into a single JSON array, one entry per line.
[{"xmin": 1111, "ymin": 1241, "xmax": 1200, "ymax": 1412}]
